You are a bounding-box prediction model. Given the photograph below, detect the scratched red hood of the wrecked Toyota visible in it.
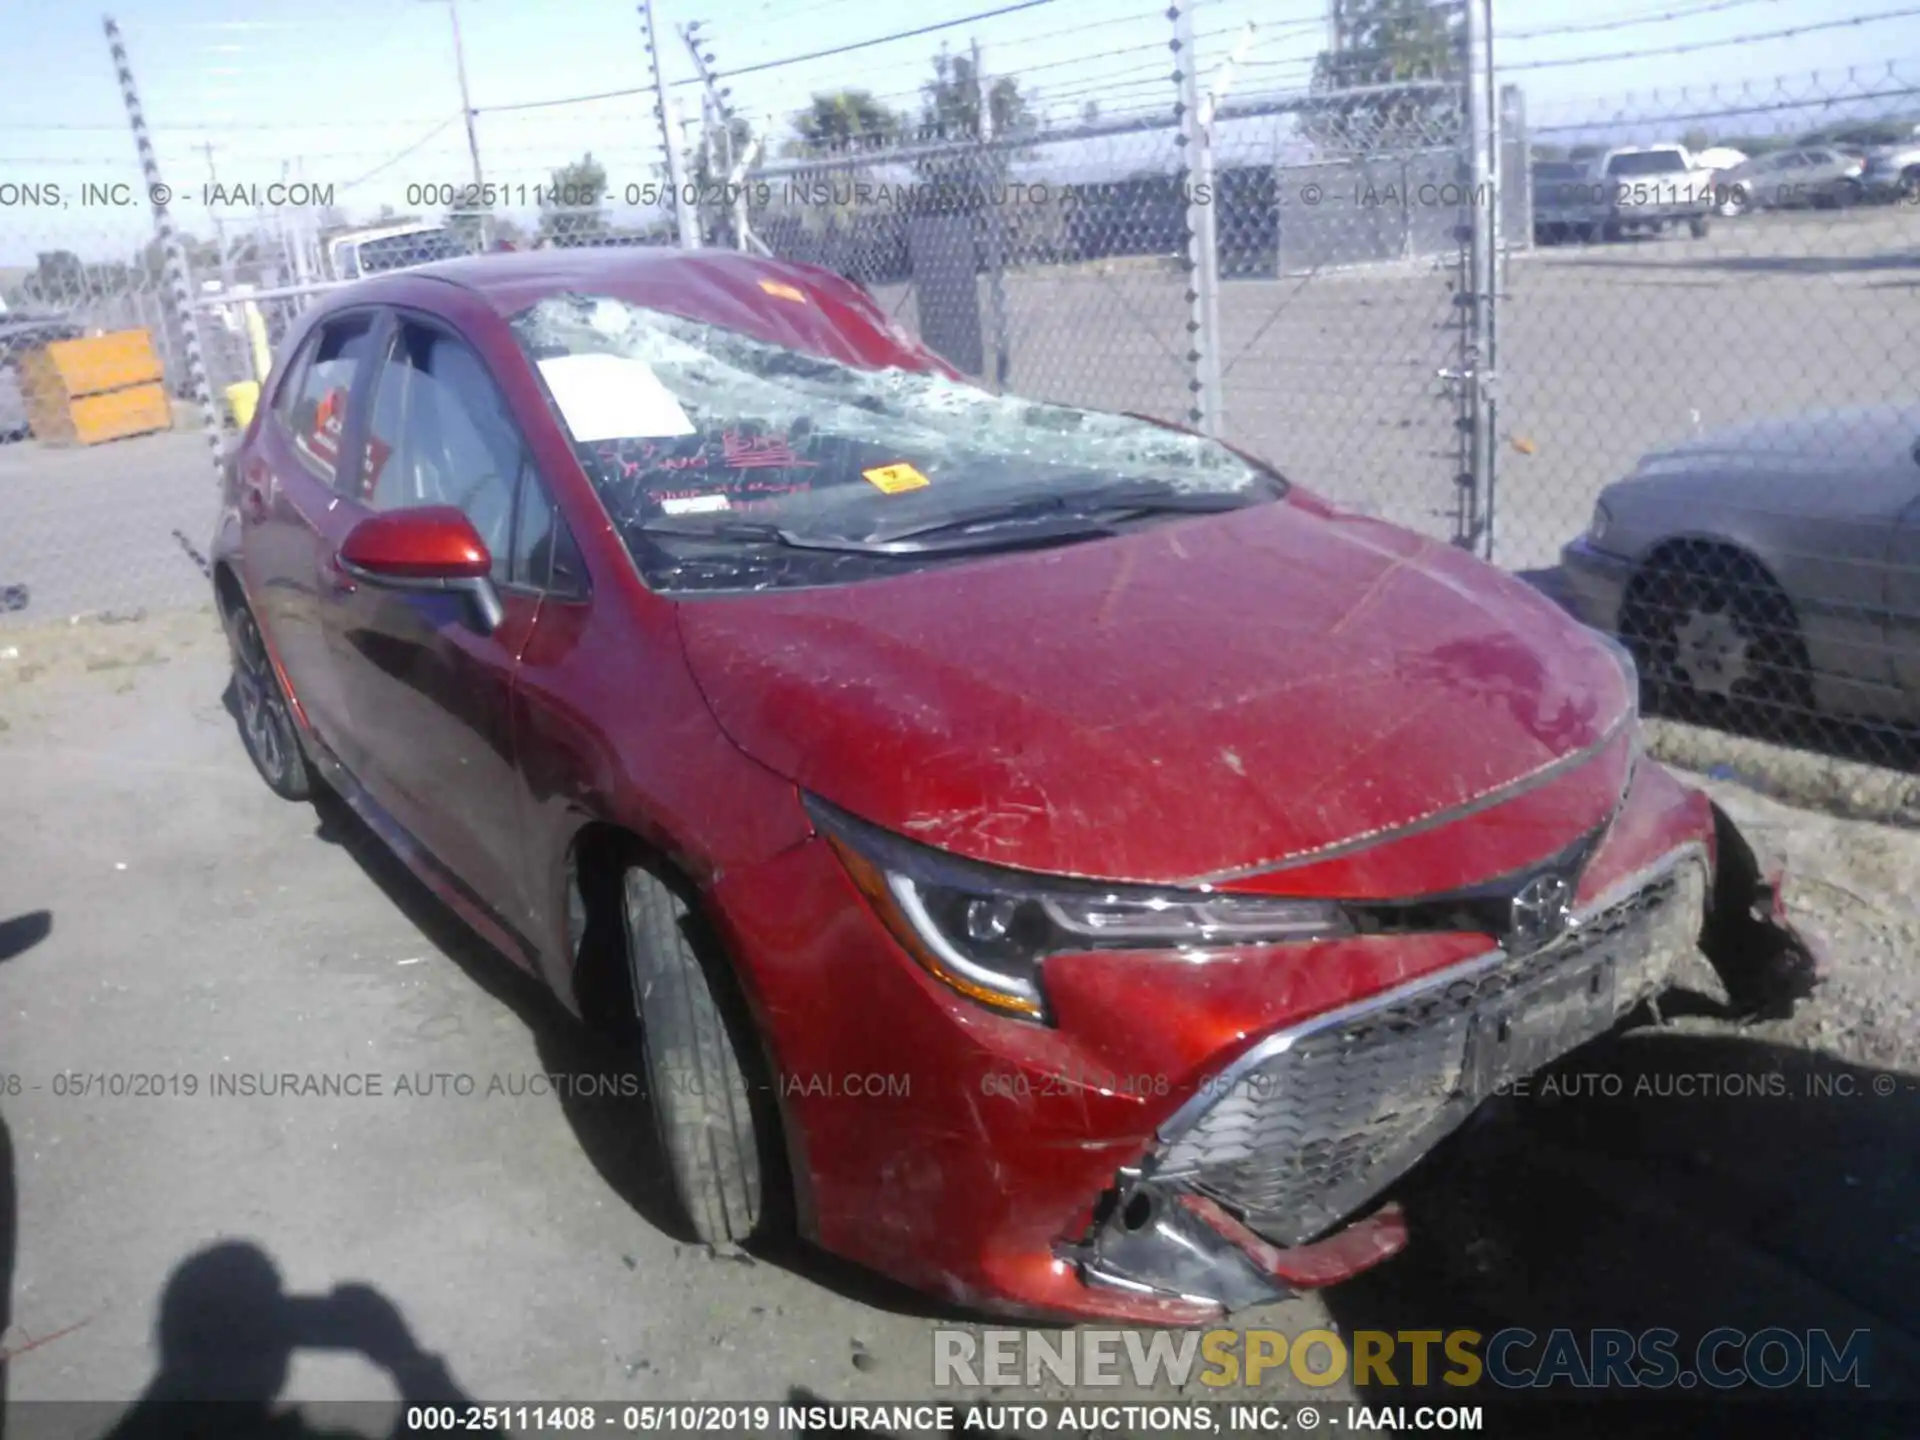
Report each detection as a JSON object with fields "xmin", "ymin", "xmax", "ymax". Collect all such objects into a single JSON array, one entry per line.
[{"xmin": 678, "ymin": 499, "xmax": 1634, "ymax": 883}]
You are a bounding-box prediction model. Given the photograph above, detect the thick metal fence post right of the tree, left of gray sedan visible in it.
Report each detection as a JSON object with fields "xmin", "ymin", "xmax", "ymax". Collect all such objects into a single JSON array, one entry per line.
[{"xmin": 1463, "ymin": 0, "xmax": 1500, "ymax": 561}]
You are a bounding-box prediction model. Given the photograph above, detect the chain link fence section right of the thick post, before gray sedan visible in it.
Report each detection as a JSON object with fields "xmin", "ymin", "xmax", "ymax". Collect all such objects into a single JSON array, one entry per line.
[{"xmin": 1496, "ymin": 63, "xmax": 1920, "ymax": 768}]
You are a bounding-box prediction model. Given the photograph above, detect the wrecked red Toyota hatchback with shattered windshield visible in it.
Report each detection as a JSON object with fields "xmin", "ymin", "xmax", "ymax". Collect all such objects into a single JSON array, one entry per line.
[{"xmin": 213, "ymin": 250, "xmax": 1809, "ymax": 1321}]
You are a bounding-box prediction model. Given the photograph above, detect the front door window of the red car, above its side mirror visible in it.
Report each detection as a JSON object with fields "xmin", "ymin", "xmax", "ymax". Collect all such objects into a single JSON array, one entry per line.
[{"xmin": 361, "ymin": 324, "xmax": 526, "ymax": 580}]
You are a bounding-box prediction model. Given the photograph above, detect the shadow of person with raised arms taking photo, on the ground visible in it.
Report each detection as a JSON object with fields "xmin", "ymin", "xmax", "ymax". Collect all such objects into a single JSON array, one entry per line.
[{"xmin": 108, "ymin": 1240, "xmax": 499, "ymax": 1440}]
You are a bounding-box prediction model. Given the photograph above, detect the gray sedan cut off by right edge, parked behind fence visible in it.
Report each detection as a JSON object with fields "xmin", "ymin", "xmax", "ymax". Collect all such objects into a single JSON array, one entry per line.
[{"xmin": 1559, "ymin": 403, "xmax": 1920, "ymax": 724}]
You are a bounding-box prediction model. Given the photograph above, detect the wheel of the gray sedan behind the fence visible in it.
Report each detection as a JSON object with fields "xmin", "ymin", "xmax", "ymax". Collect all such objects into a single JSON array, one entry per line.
[{"xmin": 1620, "ymin": 551, "xmax": 1814, "ymax": 733}]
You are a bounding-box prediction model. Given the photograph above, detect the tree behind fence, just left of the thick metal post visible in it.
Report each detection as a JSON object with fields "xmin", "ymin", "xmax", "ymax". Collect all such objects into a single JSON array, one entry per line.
[{"xmin": 1300, "ymin": 0, "xmax": 1465, "ymax": 154}]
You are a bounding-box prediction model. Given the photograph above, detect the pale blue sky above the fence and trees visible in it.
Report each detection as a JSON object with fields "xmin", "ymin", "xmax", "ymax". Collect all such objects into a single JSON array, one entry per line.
[{"xmin": 0, "ymin": 0, "xmax": 1920, "ymax": 265}]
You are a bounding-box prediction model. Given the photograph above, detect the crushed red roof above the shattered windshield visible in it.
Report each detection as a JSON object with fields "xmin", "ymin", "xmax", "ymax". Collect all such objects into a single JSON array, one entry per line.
[{"xmin": 353, "ymin": 246, "xmax": 960, "ymax": 378}]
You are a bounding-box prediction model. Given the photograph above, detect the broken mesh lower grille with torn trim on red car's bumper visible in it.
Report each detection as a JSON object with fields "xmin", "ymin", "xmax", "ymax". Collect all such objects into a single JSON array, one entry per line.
[{"xmin": 1058, "ymin": 806, "xmax": 1818, "ymax": 1311}]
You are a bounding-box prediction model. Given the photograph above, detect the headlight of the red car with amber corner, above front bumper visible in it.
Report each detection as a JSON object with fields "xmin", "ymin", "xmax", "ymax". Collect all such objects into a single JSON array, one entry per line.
[{"xmin": 806, "ymin": 797, "xmax": 1354, "ymax": 1021}]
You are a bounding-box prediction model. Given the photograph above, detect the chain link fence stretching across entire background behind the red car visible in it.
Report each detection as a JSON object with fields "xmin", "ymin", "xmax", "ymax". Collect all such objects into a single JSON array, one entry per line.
[{"xmin": 0, "ymin": 6, "xmax": 1920, "ymax": 779}]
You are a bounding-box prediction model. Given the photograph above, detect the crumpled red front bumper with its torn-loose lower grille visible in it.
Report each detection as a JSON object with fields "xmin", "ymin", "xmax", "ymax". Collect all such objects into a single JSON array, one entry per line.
[{"xmin": 714, "ymin": 764, "xmax": 1814, "ymax": 1325}]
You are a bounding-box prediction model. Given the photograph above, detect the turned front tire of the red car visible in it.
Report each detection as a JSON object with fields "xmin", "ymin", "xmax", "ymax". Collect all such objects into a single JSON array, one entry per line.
[{"xmin": 620, "ymin": 866, "xmax": 770, "ymax": 1246}]
